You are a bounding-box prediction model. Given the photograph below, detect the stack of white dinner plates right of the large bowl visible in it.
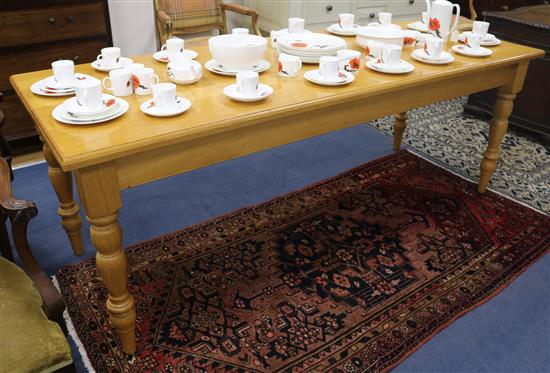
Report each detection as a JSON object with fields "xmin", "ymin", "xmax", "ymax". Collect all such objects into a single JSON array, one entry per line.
[{"xmin": 277, "ymin": 33, "xmax": 347, "ymax": 63}]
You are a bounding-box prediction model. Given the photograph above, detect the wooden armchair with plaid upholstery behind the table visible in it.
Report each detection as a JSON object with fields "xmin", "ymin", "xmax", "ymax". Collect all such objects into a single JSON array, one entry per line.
[{"xmin": 154, "ymin": 0, "xmax": 261, "ymax": 45}]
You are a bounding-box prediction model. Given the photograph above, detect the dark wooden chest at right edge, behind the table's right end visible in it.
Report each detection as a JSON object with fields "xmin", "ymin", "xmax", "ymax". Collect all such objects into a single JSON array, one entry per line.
[{"xmin": 466, "ymin": 5, "xmax": 550, "ymax": 139}]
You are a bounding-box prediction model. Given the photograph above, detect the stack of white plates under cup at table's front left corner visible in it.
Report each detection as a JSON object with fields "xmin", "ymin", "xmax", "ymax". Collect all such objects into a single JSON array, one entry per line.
[{"xmin": 52, "ymin": 94, "xmax": 129, "ymax": 125}]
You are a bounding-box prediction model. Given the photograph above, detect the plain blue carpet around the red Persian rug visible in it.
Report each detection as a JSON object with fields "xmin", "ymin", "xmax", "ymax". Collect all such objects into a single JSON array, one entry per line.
[{"xmin": 10, "ymin": 126, "xmax": 550, "ymax": 373}]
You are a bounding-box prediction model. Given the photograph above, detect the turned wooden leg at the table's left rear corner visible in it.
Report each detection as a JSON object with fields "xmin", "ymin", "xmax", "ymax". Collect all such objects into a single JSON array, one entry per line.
[{"xmin": 42, "ymin": 143, "xmax": 84, "ymax": 255}]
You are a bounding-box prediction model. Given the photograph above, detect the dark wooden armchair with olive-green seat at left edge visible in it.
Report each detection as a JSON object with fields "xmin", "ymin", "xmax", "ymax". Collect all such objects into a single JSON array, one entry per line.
[{"xmin": 0, "ymin": 159, "xmax": 75, "ymax": 373}]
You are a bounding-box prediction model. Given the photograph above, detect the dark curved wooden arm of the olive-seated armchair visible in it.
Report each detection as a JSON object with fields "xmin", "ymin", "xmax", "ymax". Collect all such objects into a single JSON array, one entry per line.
[{"xmin": 0, "ymin": 159, "xmax": 65, "ymax": 325}]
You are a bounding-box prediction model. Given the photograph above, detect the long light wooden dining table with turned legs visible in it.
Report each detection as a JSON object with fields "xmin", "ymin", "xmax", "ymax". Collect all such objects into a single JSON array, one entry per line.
[{"xmin": 10, "ymin": 21, "xmax": 544, "ymax": 354}]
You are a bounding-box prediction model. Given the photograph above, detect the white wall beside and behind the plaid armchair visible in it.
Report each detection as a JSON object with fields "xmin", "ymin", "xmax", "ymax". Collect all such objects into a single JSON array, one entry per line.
[{"xmin": 109, "ymin": 0, "xmax": 246, "ymax": 56}]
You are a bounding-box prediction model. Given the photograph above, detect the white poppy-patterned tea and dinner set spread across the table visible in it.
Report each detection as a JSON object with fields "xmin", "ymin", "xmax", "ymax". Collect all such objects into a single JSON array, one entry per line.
[{"xmin": 31, "ymin": 0, "xmax": 501, "ymax": 125}]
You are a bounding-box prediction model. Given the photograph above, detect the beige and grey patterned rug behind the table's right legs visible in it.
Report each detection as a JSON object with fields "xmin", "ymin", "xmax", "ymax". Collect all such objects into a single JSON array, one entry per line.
[{"xmin": 367, "ymin": 97, "xmax": 550, "ymax": 214}]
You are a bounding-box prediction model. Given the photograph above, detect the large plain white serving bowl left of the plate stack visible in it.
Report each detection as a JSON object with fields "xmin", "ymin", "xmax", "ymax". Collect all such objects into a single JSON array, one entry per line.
[{"xmin": 208, "ymin": 34, "xmax": 267, "ymax": 69}]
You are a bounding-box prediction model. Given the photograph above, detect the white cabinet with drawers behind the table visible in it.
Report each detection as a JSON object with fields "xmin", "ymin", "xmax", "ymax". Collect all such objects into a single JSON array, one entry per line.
[{"xmin": 243, "ymin": 0, "xmax": 426, "ymax": 32}]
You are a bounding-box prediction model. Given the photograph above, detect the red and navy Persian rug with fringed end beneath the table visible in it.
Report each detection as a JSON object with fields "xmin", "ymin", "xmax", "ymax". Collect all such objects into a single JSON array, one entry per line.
[{"xmin": 58, "ymin": 152, "xmax": 550, "ymax": 373}]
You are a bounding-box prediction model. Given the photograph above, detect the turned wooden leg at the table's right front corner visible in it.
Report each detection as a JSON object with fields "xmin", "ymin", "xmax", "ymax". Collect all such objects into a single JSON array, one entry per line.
[{"xmin": 478, "ymin": 62, "xmax": 529, "ymax": 193}]
